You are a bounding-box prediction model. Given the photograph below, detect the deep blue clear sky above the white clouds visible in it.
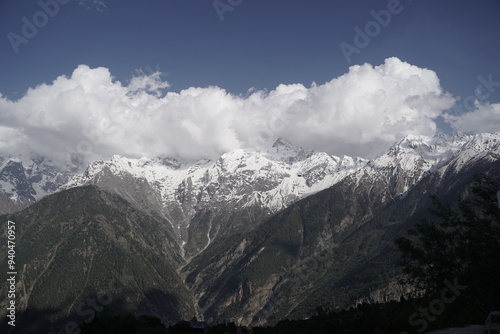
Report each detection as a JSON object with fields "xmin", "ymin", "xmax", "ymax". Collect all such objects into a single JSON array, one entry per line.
[{"xmin": 0, "ymin": 0, "xmax": 500, "ymax": 98}]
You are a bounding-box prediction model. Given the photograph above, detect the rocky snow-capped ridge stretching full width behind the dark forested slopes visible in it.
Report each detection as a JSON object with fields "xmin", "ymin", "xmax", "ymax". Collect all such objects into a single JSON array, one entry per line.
[{"xmin": 0, "ymin": 133, "xmax": 500, "ymax": 250}]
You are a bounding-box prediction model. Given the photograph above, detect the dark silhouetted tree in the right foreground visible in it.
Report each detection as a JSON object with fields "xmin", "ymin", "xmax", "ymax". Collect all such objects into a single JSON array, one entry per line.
[{"xmin": 396, "ymin": 175, "xmax": 500, "ymax": 311}]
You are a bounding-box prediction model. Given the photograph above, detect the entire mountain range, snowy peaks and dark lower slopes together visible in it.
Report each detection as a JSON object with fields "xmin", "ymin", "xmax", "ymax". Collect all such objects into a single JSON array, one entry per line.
[{"xmin": 0, "ymin": 133, "xmax": 500, "ymax": 332}]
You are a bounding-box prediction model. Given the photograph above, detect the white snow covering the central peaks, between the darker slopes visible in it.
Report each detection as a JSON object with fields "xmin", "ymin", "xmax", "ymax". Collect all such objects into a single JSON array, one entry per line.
[{"xmin": 65, "ymin": 139, "xmax": 366, "ymax": 211}]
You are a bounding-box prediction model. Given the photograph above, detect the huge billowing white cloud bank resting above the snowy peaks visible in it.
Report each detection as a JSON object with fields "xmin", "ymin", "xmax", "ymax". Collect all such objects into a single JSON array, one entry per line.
[{"xmin": 0, "ymin": 58, "xmax": 454, "ymax": 168}]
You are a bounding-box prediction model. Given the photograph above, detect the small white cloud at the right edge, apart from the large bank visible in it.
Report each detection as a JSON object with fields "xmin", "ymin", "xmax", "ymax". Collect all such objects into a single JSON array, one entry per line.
[{"xmin": 444, "ymin": 101, "xmax": 500, "ymax": 133}]
